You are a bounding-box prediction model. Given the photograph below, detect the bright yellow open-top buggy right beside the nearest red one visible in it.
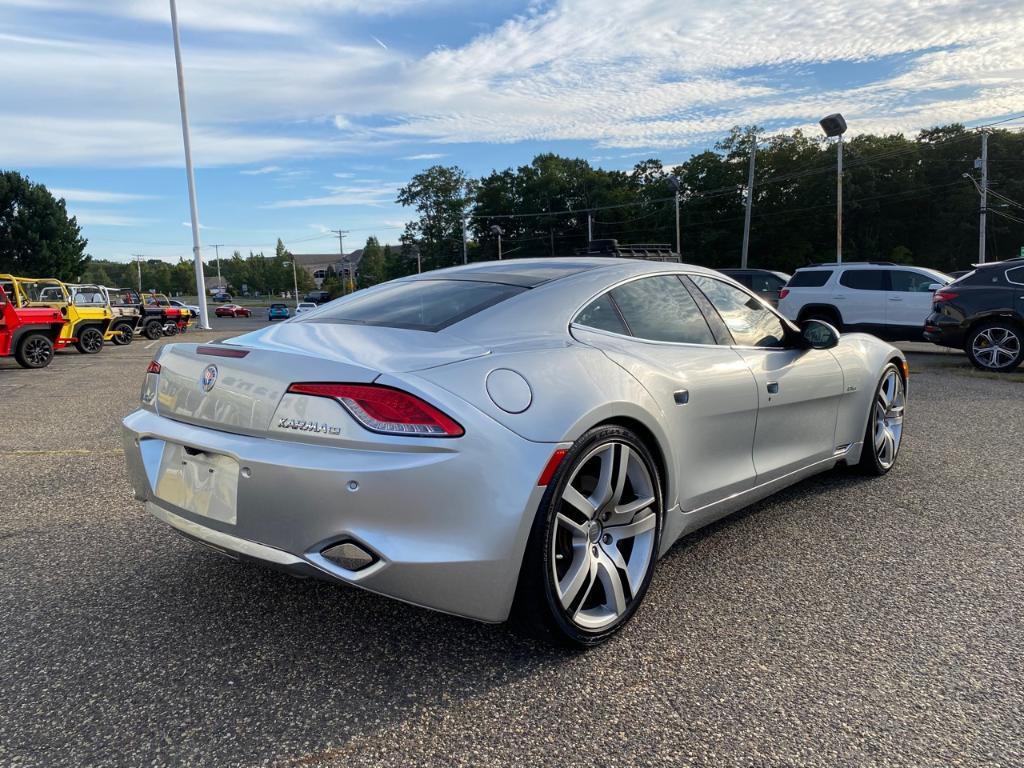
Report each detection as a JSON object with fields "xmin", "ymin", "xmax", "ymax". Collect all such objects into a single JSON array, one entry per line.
[{"xmin": 20, "ymin": 278, "xmax": 118, "ymax": 354}]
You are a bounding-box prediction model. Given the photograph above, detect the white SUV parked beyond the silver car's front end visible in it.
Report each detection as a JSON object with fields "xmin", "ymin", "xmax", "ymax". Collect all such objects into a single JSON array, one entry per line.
[{"xmin": 778, "ymin": 261, "xmax": 952, "ymax": 341}]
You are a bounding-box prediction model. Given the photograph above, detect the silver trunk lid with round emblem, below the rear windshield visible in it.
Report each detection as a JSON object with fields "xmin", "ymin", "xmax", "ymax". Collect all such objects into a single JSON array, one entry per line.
[{"xmin": 157, "ymin": 323, "xmax": 487, "ymax": 434}]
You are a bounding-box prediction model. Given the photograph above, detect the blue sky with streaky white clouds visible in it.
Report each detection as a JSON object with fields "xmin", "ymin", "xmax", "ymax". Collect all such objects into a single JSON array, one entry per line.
[{"xmin": 0, "ymin": 0, "xmax": 1024, "ymax": 260}]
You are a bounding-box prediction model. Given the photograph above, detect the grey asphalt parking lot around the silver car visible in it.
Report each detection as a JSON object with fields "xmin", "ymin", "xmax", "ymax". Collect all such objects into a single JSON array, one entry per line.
[{"xmin": 0, "ymin": 333, "xmax": 1024, "ymax": 767}]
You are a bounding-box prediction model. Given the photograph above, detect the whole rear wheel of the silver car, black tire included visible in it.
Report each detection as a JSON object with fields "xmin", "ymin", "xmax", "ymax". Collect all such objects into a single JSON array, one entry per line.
[{"xmin": 512, "ymin": 426, "xmax": 665, "ymax": 648}]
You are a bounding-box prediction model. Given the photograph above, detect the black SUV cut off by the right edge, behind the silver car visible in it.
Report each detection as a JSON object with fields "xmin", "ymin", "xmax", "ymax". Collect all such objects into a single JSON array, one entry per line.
[{"xmin": 925, "ymin": 259, "xmax": 1024, "ymax": 371}]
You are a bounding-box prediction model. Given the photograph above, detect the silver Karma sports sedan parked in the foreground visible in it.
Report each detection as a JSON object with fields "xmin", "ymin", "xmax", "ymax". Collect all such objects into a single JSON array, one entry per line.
[{"xmin": 124, "ymin": 257, "xmax": 907, "ymax": 645}]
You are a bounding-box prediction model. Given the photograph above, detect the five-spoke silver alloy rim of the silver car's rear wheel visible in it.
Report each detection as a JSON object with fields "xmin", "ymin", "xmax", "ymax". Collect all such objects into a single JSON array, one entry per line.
[{"xmin": 550, "ymin": 440, "xmax": 658, "ymax": 631}]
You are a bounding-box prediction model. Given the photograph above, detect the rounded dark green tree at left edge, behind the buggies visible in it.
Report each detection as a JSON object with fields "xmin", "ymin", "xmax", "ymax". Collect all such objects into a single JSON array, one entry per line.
[{"xmin": 0, "ymin": 171, "xmax": 90, "ymax": 281}]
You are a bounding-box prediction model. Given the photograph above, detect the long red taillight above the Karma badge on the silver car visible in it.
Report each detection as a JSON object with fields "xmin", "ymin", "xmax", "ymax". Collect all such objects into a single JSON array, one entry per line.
[{"xmin": 288, "ymin": 384, "xmax": 466, "ymax": 437}]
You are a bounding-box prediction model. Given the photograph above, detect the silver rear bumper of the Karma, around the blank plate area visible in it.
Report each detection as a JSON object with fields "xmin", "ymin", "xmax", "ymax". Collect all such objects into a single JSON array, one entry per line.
[{"xmin": 123, "ymin": 411, "xmax": 553, "ymax": 622}]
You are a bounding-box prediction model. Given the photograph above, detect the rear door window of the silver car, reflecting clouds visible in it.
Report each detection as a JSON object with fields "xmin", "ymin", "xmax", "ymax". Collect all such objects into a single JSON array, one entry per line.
[{"xmin": 611, "ymin": 274, "xmax": 715, "ymax": 344}]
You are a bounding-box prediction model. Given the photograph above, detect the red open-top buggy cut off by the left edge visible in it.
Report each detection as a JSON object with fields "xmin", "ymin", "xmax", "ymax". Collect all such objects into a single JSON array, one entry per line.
[{"xmin": 0, "ymin": 274, "xmax": 68, "ymax": 368}]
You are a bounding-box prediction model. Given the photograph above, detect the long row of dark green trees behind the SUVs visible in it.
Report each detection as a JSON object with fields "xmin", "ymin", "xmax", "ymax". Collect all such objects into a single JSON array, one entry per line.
[{"xmin": 397, "ymin": 124, "xmax": 1024, "ymax": 280}]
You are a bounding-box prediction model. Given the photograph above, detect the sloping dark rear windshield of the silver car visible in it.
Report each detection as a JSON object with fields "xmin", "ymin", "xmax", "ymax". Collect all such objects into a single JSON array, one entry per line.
[{"xmin": 298, "ymin": 280, "xmax": 528, "ymax": 331}]
